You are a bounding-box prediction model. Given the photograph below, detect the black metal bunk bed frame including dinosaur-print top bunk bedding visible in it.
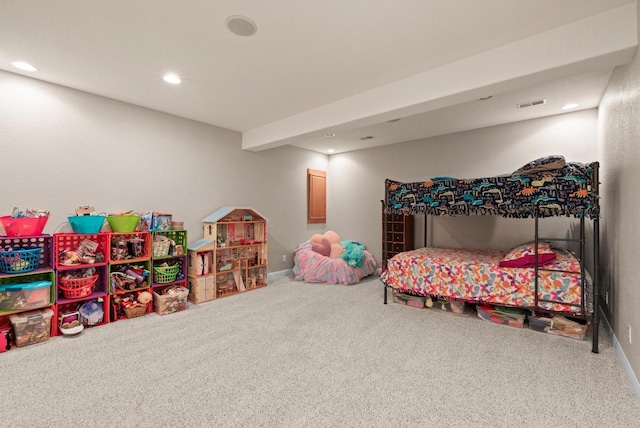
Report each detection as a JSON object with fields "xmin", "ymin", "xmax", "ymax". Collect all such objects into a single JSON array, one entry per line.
[{"xmin": 381, "ymin": 162, "xmax": 600, "ymax": 353}]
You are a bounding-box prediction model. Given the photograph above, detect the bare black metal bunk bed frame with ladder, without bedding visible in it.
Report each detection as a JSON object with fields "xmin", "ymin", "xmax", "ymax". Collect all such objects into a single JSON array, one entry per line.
[{"xmin": 382, "ymin": 162, "xmax": 601, "ymax": 354}]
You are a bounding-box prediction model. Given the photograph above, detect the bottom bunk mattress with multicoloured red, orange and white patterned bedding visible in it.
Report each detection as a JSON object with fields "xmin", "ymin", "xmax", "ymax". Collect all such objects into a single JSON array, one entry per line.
[{"xmin": 380, "ymin": 247, "xmax": 592, "ymax": 314}]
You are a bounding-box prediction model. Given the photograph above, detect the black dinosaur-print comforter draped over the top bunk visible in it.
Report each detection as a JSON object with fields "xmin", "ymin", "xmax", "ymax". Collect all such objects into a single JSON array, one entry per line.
[{"xmin": 385, "ymin": 162, "xmax": 600, "ymax": 219}]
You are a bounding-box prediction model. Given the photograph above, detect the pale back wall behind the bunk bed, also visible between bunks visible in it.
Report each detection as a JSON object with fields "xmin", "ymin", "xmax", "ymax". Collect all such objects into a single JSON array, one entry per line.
[{"xmin": 327, "ymin": 109, "xmax": 598, "ymax": 260}]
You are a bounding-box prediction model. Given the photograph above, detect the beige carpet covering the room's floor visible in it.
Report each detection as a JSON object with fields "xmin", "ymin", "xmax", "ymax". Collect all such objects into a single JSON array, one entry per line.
[{"xmin": 0, "ymin": 277, "xmax": 640, "ymax": 427}]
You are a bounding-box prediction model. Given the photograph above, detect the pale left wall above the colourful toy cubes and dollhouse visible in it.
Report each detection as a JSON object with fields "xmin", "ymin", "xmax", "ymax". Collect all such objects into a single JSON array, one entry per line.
[{"xmin": 0, "ymin": 71, "xmax": 328, "ymax": 271}]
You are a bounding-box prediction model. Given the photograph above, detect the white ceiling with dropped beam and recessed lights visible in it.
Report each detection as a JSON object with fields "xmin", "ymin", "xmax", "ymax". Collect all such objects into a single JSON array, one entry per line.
[{"xmin": 0, "ymin": 0, "xmax": 637, "ymax": 153}]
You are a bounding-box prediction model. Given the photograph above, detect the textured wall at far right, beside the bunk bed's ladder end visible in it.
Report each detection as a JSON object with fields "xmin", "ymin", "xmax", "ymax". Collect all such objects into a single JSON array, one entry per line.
[{"xmin": 599, "ymin": 15, "xmax": 640, "ymax": 378}]
